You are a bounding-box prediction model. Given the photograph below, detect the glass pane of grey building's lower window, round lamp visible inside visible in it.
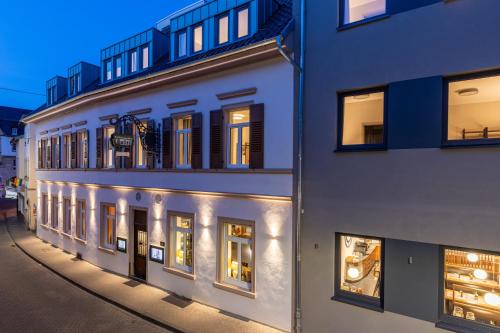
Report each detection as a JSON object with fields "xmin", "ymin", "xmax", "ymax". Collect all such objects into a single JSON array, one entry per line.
[{"xmin": 339, "ymin": 236, "xmax": 382, "ymax": 298}]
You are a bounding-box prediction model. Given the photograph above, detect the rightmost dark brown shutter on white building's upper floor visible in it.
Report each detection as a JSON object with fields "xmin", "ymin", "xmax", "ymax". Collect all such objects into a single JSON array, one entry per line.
[{"xmin": 250, "ymin": 104, "xmax": 264, "ymax": 169}]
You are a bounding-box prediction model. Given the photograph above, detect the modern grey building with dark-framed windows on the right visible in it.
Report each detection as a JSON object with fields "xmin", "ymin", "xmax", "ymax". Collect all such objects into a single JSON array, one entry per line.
[{"xmin": 300, "ymin": 0, "xmax": 500, "ymax": 333}]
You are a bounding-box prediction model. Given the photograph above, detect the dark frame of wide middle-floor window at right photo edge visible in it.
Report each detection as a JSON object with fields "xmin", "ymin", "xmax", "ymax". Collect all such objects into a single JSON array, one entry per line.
[{"xmin": 441, "ymin": 69, "xmax": 500, "ymax": 148}]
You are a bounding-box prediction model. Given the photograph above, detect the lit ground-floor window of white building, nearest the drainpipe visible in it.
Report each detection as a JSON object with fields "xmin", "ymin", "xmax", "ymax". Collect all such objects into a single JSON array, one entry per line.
[{"xmin": 220, "ymin": 222, "xmax": 255, "ymax": 291}]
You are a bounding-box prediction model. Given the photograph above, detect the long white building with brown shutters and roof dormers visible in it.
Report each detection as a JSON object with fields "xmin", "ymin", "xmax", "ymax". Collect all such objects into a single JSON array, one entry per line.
[{"xmin": 23, "ymin": 0, "xmax": 295, "ymax": 331}]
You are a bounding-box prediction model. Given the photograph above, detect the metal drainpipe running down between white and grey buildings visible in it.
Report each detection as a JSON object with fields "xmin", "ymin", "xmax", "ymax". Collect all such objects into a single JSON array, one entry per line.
[{"xmin": 276, "ymin": 0, "xmax": 305, "ymax": 333}]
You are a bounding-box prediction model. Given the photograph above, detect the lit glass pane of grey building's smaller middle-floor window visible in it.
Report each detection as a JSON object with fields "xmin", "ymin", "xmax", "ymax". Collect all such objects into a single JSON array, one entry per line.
[{"xmin": 342, "ymin": 92, "xmax": 384, "ymax": 145}]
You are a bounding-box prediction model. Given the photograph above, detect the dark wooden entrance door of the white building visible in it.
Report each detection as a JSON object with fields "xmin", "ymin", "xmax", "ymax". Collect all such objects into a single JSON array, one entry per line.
[{"xmin": 134, "ymin": 210, "xmax": 148, "ymax": 280}]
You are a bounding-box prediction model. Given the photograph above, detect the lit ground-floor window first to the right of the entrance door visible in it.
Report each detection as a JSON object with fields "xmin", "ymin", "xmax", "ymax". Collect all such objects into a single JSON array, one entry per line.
[{"xmin": 169, "ymin": 214, "xmax": 194, "ymax": 273}]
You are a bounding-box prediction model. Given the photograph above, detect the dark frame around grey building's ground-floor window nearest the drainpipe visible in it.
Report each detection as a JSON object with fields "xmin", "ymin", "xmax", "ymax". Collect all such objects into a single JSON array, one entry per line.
[{"xmin": 331, "ymin": 232, "xmax": 385, "ymax": 312}]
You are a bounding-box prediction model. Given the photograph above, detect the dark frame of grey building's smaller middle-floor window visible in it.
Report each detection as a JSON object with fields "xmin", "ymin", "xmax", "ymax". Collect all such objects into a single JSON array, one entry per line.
[{"xmin": 335, "ymin": 86, "xmax": 389, "ymax": 152}]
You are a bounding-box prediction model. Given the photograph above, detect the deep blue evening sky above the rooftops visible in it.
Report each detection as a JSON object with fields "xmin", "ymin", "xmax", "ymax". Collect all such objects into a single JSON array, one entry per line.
[{"xmin": 0, "ymin": 0, "xmax": 195, "ymax": 108}]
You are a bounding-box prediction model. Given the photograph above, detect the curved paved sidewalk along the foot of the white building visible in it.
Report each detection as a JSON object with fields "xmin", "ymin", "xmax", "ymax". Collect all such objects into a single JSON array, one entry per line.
[{"xmin": 8, "ymin": 218, "xmax": 282, "ymax": 333}]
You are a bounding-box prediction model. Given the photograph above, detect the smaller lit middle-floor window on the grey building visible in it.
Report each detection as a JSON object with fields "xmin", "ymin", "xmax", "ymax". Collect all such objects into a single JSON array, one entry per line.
[{"xmin": 338, "ymin": 90, "xmax": 386, "ymax": 150}]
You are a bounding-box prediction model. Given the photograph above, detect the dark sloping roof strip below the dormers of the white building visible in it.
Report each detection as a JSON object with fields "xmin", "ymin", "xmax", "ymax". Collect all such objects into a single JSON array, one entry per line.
[{"xmin": 27, "ymin": 0, "xmax": 293, "ymax": 114}]
